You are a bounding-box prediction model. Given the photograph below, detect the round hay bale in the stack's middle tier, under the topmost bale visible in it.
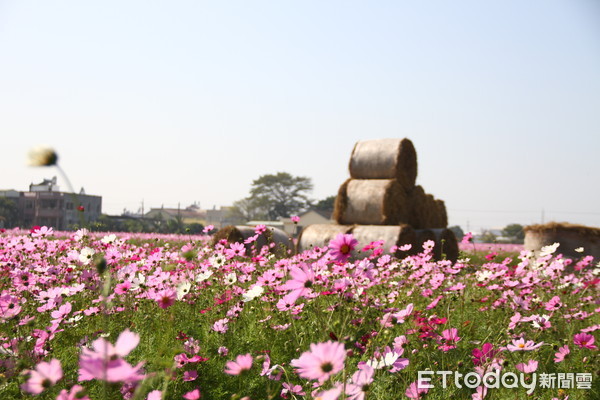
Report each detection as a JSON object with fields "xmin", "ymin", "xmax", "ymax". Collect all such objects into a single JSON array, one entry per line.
[{"xmin": 333, "ymin": 179, "xmax": 410, "ymax": 225}]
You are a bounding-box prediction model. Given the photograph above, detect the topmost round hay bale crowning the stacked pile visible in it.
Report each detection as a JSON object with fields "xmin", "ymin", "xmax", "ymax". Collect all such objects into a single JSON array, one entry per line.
[{"xmin": 349, "ymin": 138, "xmax": 417, "ymax": 189}]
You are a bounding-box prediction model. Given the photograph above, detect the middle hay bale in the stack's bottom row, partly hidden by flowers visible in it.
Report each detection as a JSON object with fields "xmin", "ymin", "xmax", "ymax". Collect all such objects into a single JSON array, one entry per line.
[{"xmin": 352, "ymin": 224, "xmax": 417, "ymax": 257}]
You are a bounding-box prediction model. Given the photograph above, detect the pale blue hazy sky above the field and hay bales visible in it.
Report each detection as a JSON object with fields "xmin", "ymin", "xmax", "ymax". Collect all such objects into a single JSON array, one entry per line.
[{"xmin": 0, "ymin": 0, "xmax": 600, "ymax": 230}]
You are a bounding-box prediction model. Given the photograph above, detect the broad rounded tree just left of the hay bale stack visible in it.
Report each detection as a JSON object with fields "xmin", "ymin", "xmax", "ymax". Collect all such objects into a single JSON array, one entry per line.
[{"xmin": 247, "ymin": 172, "xmax": 313, "ymax": 220}]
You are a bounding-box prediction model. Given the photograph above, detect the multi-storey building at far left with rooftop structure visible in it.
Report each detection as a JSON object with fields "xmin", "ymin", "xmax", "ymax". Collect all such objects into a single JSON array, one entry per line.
[{"xmin": 0, "ymin": 177, "xmax": 102, "ymax": 230}]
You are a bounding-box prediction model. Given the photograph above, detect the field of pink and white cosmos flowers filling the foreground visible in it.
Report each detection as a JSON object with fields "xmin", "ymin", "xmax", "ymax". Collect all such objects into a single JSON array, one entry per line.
[{"xmin": 0, "ymin": 226, "xmax": 600, "ymax": 400}]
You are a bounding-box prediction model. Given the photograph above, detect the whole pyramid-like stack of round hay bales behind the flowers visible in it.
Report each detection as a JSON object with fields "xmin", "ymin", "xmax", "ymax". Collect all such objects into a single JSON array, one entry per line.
[{"xmin": 298, "ymin": 138, "xmax": 458, "ymax": 261}]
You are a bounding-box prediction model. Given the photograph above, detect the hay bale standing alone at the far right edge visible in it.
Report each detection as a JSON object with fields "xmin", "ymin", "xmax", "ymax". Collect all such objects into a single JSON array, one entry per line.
[{"xmin": 523, "ymin": 222, "xmax": 600, "ymax": 260}]
